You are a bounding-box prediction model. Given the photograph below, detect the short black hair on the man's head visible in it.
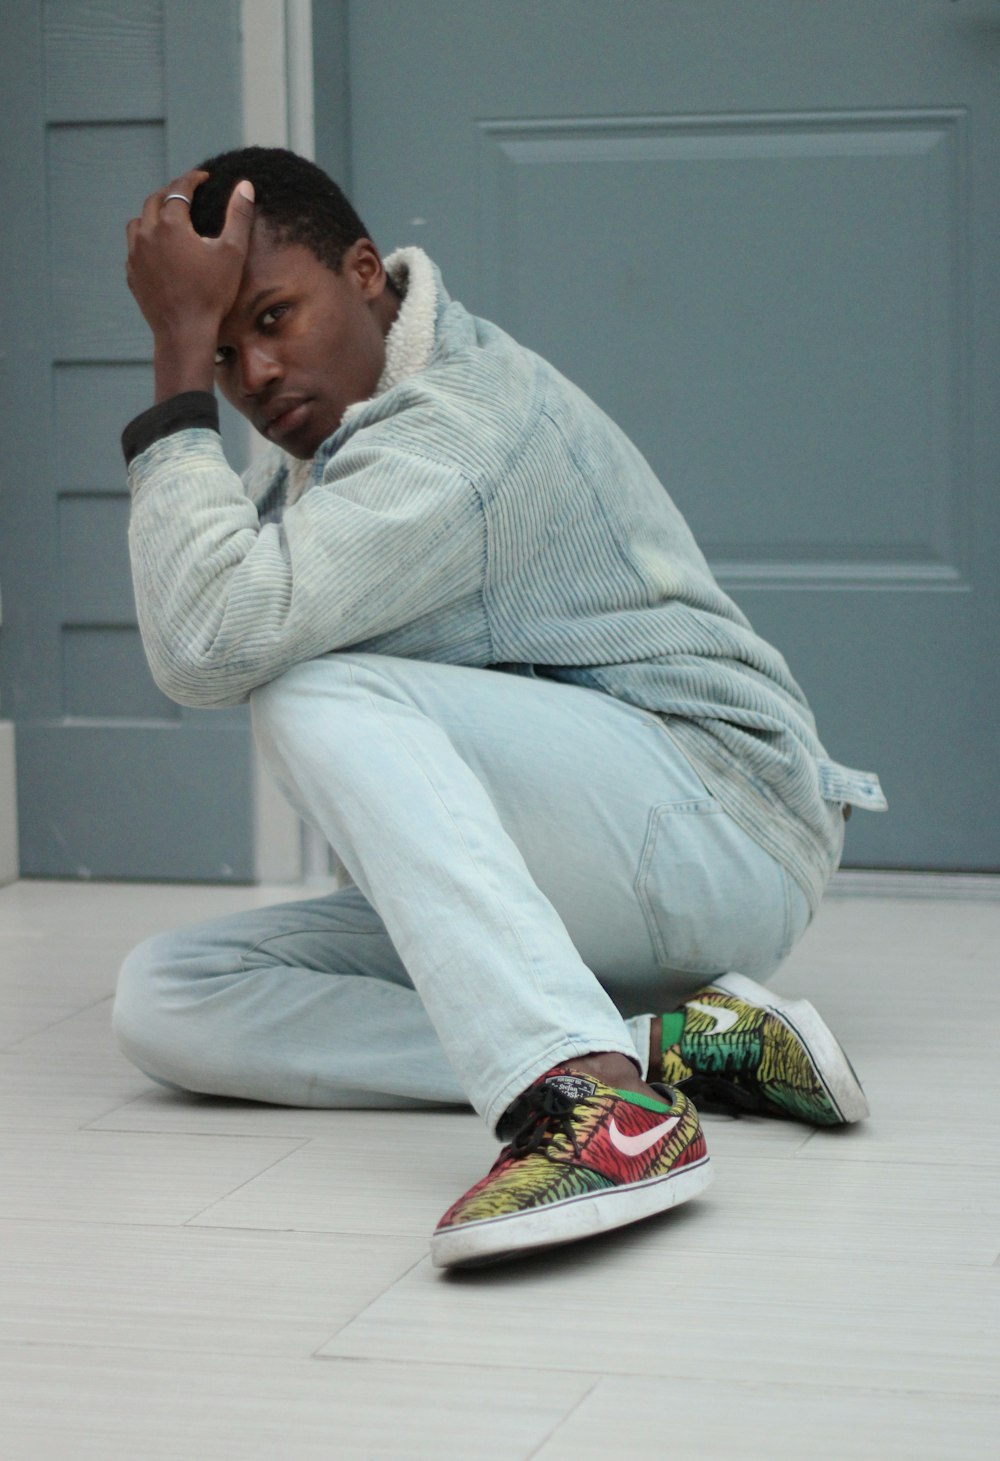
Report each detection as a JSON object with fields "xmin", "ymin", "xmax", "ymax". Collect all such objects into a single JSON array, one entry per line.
[{"xmin": 192, "ymin": 148, "xmax": 371, "ymax": 273}]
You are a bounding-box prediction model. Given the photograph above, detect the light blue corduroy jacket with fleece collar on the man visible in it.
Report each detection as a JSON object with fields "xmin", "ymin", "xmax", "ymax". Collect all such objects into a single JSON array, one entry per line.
[{"xmin": 130, "ymin": 250, "xmax": 885, "ymax": 909}]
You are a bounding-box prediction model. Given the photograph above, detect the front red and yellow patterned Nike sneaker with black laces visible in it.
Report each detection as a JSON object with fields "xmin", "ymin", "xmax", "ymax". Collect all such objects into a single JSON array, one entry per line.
[{"xmin": 431, "ymin": 1067, "xmax": 712, "ymax": 1268}]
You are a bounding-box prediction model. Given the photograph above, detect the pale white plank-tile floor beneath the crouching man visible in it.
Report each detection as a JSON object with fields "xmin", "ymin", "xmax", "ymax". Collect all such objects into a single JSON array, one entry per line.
[{"xmin": 0, "ymin": 875, "xmax": 1000, "ymax": 1461}]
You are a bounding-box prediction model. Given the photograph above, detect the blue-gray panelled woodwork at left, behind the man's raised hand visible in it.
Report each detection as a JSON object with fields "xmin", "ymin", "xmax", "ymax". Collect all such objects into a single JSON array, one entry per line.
[{"xmin": 0, "ymin": 0, "xmax": 253, "ymax": 880}]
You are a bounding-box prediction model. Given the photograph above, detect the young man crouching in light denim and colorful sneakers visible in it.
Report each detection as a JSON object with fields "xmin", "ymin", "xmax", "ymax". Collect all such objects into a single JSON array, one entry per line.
[{"xmin": 115, "ymin": 148, "xmax": 883, "ymax": 1265}]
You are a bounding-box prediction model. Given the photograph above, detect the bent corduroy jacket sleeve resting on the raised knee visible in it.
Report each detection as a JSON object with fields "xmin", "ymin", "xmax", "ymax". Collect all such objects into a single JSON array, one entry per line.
[{"xmin": 129, "ymin": 428, "xmax": 485, "ymax": 706}]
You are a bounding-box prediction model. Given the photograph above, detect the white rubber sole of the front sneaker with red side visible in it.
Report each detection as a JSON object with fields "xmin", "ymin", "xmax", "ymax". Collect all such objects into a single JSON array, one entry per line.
[{"xmin": 431, "ymin": 1157, "xmax": 715, "ymax": 1268}]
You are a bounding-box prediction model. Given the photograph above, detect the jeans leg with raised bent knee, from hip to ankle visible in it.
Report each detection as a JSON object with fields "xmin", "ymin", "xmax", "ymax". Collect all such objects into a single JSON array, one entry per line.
[{"xmin": 253, "ymin": 655, "xmax": 812, "ymax": 1126}]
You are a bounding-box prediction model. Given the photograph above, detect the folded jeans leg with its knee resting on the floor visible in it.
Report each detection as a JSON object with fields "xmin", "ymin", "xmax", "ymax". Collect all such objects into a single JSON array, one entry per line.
[{"xmin": 114, "ymin": 888, "xmax": 466, "ymax": 1107}]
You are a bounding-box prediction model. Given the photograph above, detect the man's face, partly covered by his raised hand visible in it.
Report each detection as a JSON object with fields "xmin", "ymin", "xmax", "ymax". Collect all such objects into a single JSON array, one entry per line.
[{"xmin": 215, "ymin": 221, "xmax": 396, "ymax": 459}]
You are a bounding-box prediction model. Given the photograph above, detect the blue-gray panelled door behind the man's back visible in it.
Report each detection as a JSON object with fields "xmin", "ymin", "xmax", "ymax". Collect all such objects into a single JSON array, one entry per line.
[{"xmin": 316, "ymin": 0, "xmax": 1000, "ymax": 869}]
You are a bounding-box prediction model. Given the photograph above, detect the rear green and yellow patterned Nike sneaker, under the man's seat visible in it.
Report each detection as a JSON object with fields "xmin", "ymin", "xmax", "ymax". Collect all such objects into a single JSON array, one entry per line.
[{"xmin": 659, "ymin": 974, "xmax": 868, "ymax": 1126}]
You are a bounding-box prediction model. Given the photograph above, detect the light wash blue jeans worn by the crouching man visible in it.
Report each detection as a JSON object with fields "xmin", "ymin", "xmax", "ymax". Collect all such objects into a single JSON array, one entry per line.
[{"xmin": 114, "ymin": 655, "xmax": 808, "ymax": 1129}]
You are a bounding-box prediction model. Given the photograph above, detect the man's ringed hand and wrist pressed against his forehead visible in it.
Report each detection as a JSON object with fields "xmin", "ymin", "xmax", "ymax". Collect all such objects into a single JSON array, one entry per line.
[{"xmin": 126, "ymin": 169, "xmax": 253, "ymax": 400}]
